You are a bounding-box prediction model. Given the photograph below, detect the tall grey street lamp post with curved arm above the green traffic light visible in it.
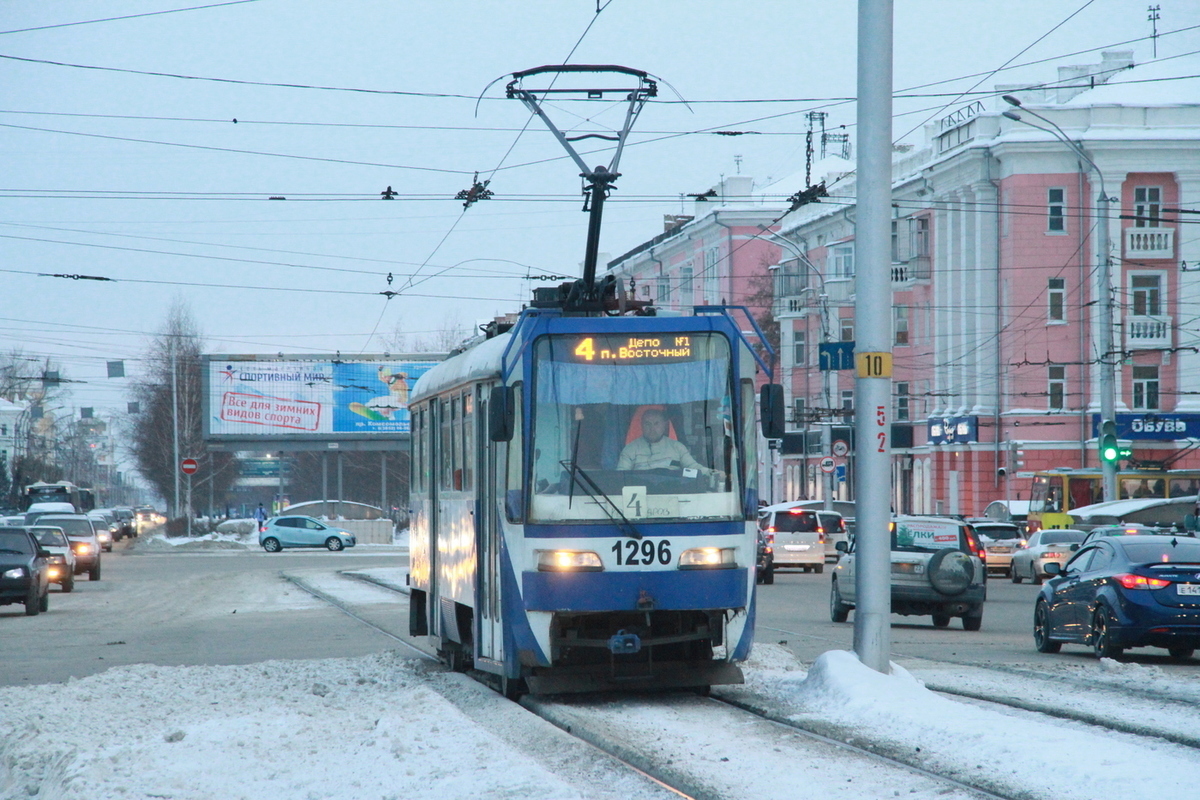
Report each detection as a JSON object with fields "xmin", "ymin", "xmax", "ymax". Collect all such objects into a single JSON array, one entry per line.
[{"xmin": 1003, "ymin": 95, "xmax": 1117, "ymax": 501}]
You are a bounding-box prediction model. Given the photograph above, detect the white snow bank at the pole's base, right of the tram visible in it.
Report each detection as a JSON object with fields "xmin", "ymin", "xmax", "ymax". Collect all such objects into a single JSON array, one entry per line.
[{"xmin": 734, "ymin": 650, "xmax": 1200, "ymax": 800}]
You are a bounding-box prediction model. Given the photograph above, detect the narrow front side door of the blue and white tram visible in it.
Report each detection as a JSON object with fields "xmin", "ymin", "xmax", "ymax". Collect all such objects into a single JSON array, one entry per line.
[{"xmin": 475, "ymin": 385, "xmax": 504, "ymax": 662}]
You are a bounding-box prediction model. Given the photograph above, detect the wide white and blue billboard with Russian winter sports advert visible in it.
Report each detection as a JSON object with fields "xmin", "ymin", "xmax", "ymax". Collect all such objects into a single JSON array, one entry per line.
[{"xmin": 204, "ymin": 355, "xmax": 442, "ymax": 440}]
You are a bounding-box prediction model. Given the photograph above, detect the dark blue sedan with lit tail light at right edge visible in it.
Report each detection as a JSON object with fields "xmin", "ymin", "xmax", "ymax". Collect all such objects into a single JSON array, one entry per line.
[{"xmin": 1033, "ymin": 535, "xmax": 1200, "ymax": 660}]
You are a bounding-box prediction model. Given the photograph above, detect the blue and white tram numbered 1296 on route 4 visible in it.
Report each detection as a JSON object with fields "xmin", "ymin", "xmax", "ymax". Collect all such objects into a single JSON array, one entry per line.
[{"xmin": 409, "ymin": 308, "xmax": 781, "ymax": 694}]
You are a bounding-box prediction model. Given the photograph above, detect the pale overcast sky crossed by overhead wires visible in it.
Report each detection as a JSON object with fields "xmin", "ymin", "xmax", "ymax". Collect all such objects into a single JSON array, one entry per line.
[{"xmin": 0, "ymin": 0, "xmax": 1200, "ymax": 415}]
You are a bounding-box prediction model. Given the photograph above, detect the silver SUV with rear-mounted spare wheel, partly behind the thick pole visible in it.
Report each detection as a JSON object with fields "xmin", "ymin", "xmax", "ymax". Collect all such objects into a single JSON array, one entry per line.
[{"xmin": 829, "ymin": 516, "xmax": 988, "ymax": 631}]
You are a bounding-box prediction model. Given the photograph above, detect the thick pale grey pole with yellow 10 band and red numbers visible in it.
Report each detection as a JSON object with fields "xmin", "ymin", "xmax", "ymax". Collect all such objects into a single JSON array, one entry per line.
[{"xmin": 854, "ymin": 0, "xmax": 892, "ymax": 674}]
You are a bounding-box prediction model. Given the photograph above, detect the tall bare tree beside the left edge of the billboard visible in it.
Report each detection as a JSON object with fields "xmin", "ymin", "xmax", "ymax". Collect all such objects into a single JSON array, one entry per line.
[{"xmin": 130, "ymin": 301, "xmax": 238, "ymax": 522}]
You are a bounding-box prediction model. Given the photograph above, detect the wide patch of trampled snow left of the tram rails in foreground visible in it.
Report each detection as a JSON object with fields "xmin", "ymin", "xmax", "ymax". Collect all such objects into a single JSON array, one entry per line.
[{"xmin": 0, "ymin": 652, "xmax": 600, "ymax": 800}]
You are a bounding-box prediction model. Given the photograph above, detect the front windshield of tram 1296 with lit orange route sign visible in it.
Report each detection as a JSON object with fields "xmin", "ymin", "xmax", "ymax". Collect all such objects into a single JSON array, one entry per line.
[{"xmin": 529, "ymin": 332, "xmax": 752, "ymax": 522}]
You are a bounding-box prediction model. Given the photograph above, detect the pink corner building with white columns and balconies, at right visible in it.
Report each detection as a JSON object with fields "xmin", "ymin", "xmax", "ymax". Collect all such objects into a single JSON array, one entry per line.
[{"xmin": 775, "ymin": 53, "xmax": 1200, "ymax": 515}]
